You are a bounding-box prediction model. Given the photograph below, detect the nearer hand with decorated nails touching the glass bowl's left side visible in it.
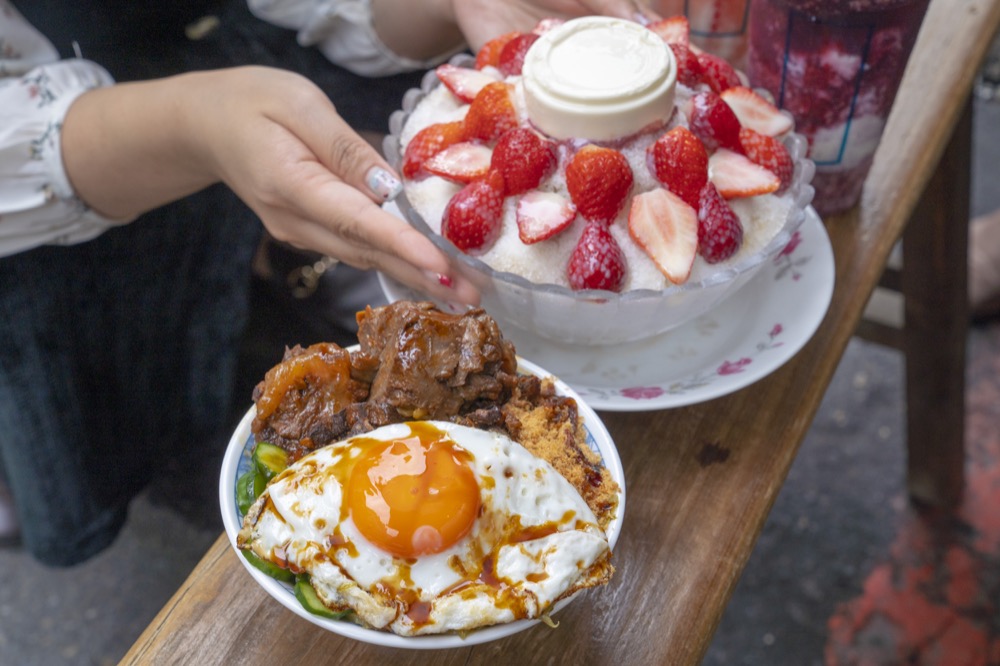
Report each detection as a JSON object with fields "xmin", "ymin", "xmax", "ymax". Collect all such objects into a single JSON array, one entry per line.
[{"xmin": 195, "ymin": 67, "xmax": 479, "ymax": 304}]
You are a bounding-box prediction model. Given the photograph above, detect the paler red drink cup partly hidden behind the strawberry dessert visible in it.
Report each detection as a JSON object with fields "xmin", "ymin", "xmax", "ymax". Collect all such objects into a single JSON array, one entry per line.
[{"xmin": 650, "ymin": 0, "xmax": 751, "ymax": 69}]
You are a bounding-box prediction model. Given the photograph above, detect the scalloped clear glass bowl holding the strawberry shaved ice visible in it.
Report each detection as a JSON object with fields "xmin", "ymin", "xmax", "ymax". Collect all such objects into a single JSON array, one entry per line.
[{"xmin": 383, "ymin": 56, "xmax": 814, "ymax": 345}]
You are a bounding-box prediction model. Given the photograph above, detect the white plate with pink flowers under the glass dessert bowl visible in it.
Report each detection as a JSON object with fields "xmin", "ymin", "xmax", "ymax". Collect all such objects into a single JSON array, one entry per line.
[{"xmin": 379, "ymin": 207, "xmax": 834, "ymax": 412}]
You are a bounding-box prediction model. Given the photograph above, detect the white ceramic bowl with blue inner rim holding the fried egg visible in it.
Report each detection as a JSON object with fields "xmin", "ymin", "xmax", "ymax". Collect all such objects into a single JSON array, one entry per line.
[{"xmin": 219, "ymin": 358, "xmax": 625, "ymax": 650}]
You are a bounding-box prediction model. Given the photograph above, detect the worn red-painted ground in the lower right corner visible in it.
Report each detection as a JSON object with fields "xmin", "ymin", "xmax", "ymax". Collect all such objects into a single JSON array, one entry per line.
[{"xmin": 825, "ymin": 324, "xmax": 1000, "ymax": 666}]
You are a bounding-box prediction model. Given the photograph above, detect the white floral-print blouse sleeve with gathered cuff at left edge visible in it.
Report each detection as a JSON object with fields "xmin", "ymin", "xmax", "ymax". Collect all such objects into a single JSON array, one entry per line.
[{"xmin": 0, "ymin": 0, "xmax": 122, "ymax": 257}]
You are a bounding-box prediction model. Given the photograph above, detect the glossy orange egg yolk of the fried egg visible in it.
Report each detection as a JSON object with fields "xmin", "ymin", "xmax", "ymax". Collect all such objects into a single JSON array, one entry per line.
[{"xmin": 347, "ymin": 431, "xmax": 480, "ymax": 558}]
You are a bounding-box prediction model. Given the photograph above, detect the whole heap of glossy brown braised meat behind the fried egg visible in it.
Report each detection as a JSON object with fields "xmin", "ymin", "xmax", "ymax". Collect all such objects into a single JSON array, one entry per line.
[{"xmin": 252, "ymin": 302, "xmax": 517, "ymax": 460}]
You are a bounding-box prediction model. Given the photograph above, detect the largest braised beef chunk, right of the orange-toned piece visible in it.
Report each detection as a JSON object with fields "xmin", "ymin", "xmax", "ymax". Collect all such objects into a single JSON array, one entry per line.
[{"xmin": 358, "ymin": 303, "xmax": 517, "ymax": 419}]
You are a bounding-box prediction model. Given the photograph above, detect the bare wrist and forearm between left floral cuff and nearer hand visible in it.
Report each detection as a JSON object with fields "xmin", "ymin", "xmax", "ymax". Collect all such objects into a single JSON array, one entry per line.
[{"xmin": 62, "ymin": 73, "xmax": 218, "ymax": 219}]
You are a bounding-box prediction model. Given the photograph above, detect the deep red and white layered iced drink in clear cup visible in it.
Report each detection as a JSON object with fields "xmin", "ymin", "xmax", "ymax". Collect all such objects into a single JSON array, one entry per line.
[{"xmin": 747, "ymin": 0, "xmax": 928, "ymax": 214}]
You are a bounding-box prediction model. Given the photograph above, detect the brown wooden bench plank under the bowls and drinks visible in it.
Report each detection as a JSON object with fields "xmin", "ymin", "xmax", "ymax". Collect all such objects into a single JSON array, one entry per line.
[{"xmin": 123, "ymin": 0, "xmax": 1000, "ymax": 665}]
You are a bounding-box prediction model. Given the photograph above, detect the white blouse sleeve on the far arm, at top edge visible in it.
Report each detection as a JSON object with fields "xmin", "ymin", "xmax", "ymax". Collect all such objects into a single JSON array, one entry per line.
[{"xmin": 247, "ymin": 0, "xmax": 455, "ymax": 76}]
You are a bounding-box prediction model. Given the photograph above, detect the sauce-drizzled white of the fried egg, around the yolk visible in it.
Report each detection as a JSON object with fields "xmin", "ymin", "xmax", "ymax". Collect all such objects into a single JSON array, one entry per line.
[{"xmin": 241, "ymin": 422, "xmax": 610, "ymax": 636}]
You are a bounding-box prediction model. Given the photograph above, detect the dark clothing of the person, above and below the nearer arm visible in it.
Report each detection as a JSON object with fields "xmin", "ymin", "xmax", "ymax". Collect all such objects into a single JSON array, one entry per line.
[{"xmin": 0, "ymin": 0, "xmax": 420, "ymax": 566}]
